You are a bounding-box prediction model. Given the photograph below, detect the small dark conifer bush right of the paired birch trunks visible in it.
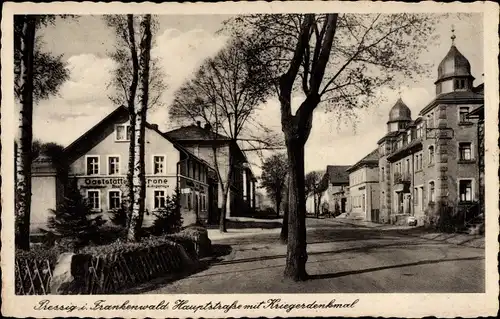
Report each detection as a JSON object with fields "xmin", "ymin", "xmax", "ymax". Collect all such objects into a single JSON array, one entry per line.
[{"xmin": 151, "ymin": 194, "xmax": 182, "ymax": 235}]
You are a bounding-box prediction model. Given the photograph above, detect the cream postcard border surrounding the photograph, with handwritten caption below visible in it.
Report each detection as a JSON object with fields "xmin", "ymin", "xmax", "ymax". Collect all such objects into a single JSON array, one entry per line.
[{"xmin": 1, "ymin": 1, "xmax": 499, "ymax": 318}]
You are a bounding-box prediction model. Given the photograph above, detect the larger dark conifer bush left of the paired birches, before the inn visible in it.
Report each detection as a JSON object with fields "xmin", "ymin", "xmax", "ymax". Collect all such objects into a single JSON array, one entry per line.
[{"xmin": 45, "ymin": 180, "xmax": 106, "ymax": 248}]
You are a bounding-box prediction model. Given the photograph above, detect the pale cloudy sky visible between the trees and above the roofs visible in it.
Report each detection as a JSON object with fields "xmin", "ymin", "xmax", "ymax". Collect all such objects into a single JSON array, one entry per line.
[{"xmin": 33, "ymin": 14, "xmax": 484, "ymax": 175}]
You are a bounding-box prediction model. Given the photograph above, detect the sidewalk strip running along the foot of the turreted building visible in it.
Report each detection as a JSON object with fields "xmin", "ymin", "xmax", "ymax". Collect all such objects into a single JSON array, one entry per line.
[{"xmin": 335, "ymin": 217, "xmax": 485, "ymax": 248}]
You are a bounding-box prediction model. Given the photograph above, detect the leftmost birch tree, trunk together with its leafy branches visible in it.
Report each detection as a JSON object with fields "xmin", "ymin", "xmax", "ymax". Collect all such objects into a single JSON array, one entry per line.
[{"xmin": 14, "ymin": 15, "xmax": 69, "ymax": 250}]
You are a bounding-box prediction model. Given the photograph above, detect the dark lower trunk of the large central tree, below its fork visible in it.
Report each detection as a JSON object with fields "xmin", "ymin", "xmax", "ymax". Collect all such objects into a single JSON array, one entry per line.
[{"xmin": 285, "ymin": 139, "xmax": 307, "ymax": 281}]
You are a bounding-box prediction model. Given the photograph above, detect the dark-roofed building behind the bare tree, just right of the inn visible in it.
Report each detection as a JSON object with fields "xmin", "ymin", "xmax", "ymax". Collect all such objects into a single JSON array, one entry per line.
[{"xmin": 165, "ymin": 122, "xmax": 257, "ymax": 223}]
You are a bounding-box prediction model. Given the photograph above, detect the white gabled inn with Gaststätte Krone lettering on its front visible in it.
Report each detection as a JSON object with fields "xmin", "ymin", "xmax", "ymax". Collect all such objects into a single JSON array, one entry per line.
[{"xmin": 31, "ymin": 107, "xmax": 216, "ymax": 232}]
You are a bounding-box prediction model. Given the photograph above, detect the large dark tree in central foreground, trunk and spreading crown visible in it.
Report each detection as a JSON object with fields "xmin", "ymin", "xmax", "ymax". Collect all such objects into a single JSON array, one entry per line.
[{"xmin": 225, "ymin": 13, "xmax": 436, "ymax": 280}]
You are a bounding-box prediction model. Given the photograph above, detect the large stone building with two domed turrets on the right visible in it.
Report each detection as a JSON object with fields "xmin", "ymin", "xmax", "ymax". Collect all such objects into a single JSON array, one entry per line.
[{"xmin": 378, "ymin": 30, "xmax": 484, "ymax": 225}]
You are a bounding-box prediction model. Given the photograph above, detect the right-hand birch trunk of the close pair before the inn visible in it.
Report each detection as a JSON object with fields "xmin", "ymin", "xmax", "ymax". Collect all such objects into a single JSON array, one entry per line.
[{"xmin": 127, "ymin": 14, "xmax": 152, "ymax": 241}]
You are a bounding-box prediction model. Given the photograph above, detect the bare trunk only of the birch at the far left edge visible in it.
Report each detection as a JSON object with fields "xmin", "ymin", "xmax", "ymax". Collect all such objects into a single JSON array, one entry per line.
[{"xmin": 15, "ymin": 16, "xmax": 36, "ymax": 250}]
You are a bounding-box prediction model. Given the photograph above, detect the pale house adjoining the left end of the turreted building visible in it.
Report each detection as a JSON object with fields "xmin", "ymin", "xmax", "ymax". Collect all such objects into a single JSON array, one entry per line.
[{"xmin": 347, "ymin": 149, "xmax": 380, "ymax": 222}]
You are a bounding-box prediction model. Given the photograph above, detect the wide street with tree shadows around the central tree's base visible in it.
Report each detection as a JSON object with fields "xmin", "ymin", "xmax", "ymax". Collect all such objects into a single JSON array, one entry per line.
[{"xmin": 134, "ymin": 218, "xmax": 485, "ymax": 294}]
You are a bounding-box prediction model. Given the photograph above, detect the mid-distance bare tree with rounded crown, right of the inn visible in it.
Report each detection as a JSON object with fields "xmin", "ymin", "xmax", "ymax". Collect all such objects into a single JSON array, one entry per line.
[{"xmin": 170, "ymin": 39, "xmax": 279, "ymax": 232}]
